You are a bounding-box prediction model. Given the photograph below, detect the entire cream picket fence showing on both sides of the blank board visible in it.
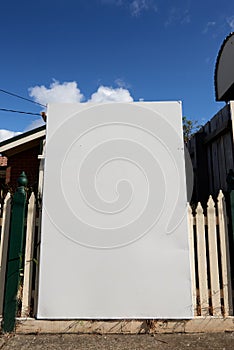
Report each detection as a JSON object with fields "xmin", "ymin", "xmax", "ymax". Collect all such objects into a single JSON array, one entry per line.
[{"xmin": 0, "ymin": 191, "xmax": 233, "ymax": 318}]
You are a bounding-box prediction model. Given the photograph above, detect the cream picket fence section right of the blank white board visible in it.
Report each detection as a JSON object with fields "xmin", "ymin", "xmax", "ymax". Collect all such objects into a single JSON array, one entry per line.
[{"xmin": 188, "ymin": 191, "xmax": 233, "ymax": 316}]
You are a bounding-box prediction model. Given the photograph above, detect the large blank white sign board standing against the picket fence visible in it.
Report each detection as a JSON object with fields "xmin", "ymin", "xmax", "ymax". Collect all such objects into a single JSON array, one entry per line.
[{"xmin": 37, "ymin": 102, "xmax": 193, "ymax": 319}]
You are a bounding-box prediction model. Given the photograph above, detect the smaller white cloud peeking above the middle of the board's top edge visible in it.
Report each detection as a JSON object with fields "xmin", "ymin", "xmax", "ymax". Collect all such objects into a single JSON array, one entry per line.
[{"xmin": 89, "ymin": 86, "xmax": 133, "ymax": 103}]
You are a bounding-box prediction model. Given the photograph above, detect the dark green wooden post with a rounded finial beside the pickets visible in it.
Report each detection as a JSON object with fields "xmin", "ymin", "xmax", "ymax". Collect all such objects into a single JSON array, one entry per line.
[{"xmin": 2, "ymin": 172, "xmax": 28, "ymax": 332}]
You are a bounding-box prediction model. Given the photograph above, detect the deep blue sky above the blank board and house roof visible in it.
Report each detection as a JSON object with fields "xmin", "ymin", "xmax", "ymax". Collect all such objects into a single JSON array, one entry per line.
[{"xmin": 0, "ymin": 0, "xmax": 234, "ymax": 139}]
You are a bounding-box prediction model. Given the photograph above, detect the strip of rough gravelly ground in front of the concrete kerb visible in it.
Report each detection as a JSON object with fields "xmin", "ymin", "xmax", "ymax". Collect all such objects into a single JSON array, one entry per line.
[{"xmin": 0, "ymin": 332, "xmax": 234, "ymax": 350}]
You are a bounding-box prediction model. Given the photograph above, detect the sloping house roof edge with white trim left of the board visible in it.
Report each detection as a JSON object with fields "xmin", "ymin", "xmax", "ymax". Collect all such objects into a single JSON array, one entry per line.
[{"xmin": 0, "ymin": 125, "xmax": 46, "ymax": 157}]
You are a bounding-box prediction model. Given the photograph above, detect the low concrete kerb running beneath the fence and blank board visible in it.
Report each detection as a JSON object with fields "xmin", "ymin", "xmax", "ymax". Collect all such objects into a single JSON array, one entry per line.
[{"xmin": 0, "ymin": 316, "xmax": 234, "ymax": 334}]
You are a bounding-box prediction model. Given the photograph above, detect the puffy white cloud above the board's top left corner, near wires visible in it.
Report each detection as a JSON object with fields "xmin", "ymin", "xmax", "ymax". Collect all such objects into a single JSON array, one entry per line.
[{"xmin": 29, "ymin": 80, "xmax": 84, "ymax": 105}]
